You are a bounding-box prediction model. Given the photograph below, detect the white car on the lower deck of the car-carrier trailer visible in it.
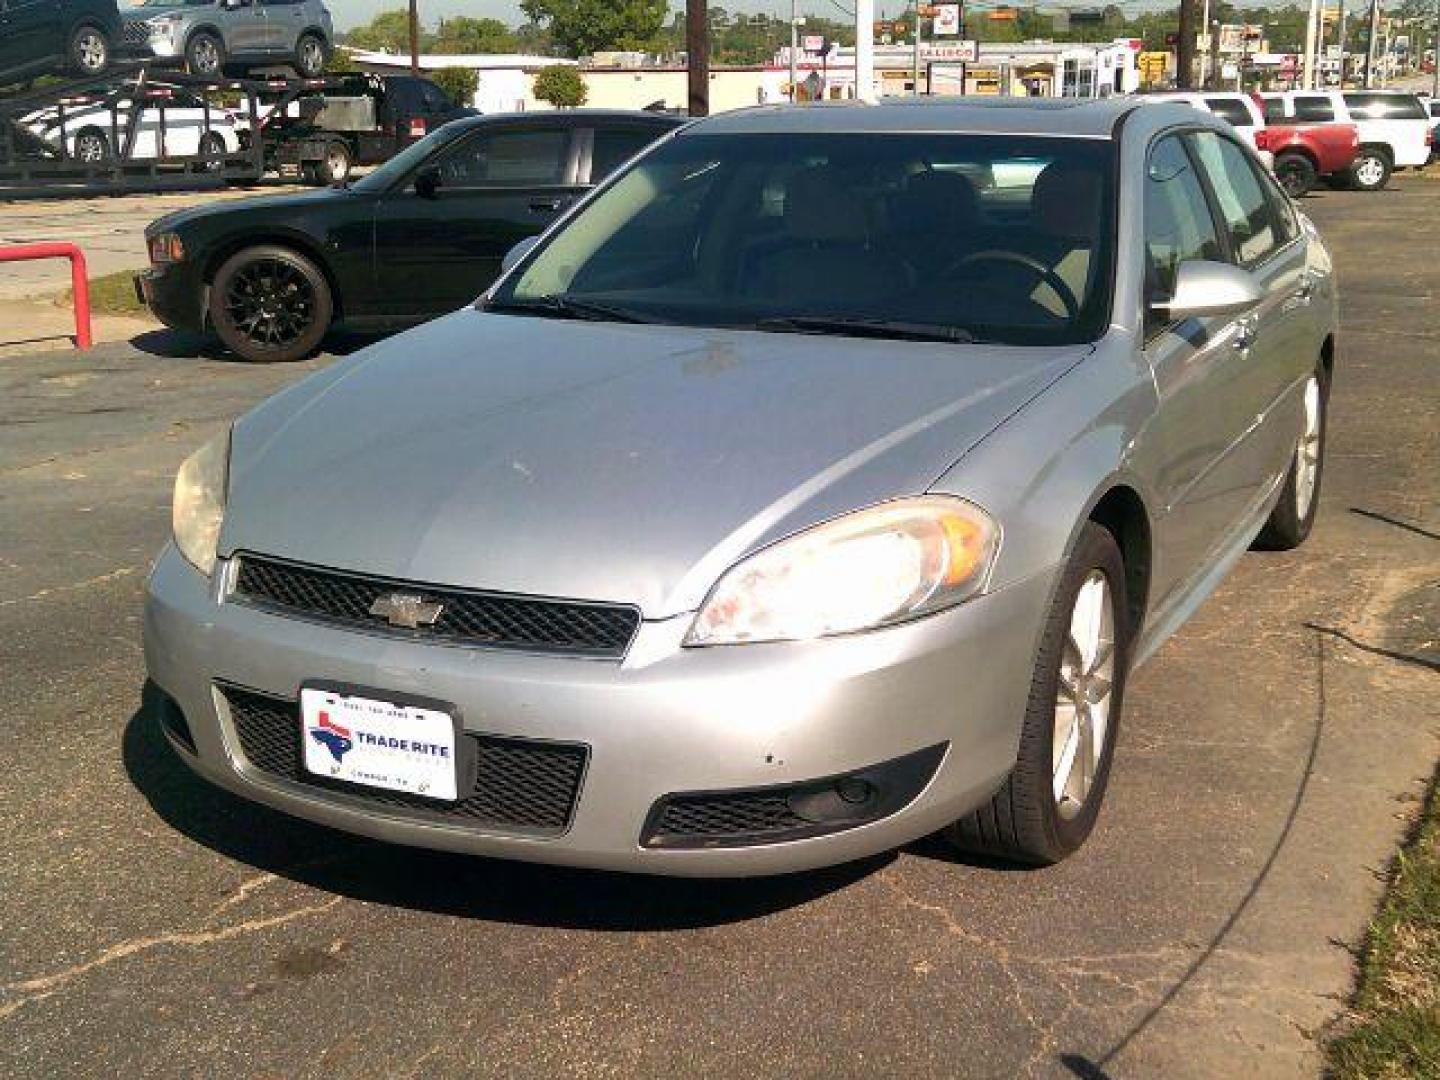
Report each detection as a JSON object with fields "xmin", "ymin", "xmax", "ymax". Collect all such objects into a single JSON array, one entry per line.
[{"xmin": 20, "ymin": 88, "xmax": 241, "ymax": 166}]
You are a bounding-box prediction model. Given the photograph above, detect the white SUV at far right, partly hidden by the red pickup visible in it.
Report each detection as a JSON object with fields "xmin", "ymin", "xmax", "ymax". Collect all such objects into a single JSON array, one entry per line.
[{"xmin": 1260, "ymin": 91, "xmax": 1431, "ymax": 192}]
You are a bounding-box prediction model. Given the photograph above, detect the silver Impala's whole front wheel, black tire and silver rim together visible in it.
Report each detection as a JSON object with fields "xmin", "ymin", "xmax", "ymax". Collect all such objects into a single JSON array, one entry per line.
[{"xmin": 945, "ymin": 521, "xmax": 1130, "ymax": 865}]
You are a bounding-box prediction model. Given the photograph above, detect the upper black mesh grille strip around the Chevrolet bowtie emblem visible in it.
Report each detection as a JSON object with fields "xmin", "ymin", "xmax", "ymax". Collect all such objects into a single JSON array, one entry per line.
[{"xmin": 233, "ymin": 554, "xmax": 639, "ymax": 658}]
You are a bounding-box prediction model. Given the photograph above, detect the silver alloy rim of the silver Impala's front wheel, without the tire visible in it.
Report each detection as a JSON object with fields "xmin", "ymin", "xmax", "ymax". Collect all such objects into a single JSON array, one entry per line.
[{"xmin": 1050, "ymin": 570, "xmax": 1115, "ymax": 819}]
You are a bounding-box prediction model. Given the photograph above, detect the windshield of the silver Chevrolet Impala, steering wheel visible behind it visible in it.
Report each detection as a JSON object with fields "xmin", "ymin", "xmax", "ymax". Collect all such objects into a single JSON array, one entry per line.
[{"xmin": 485, "ymin": 132, "xmax": 1115, "ymax": 344}]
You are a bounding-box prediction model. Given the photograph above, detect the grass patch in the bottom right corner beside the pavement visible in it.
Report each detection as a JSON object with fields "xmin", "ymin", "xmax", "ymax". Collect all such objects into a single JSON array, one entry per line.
[{"xmin": 1326, "ymin": 775, "xmax": 1440, "ymax": 1080}]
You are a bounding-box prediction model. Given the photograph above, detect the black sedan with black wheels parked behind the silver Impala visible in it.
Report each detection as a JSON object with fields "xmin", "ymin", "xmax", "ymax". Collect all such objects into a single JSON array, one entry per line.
[{"xmin": 135, "ymin": 109, "xmax": 685, "ymax": 360}]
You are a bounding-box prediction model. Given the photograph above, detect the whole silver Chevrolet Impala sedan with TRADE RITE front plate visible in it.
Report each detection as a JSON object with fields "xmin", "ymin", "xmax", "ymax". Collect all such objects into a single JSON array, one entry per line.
[{"xmin": 145, "ymin": 99, "xmax": 1336, "ymax": 876}]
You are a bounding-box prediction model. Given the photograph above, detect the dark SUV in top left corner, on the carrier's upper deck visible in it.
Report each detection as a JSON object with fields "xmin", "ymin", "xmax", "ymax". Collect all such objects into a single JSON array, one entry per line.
[{"xmin": 0, "ymin": 0, "xmax": 121, "ymax": 85}]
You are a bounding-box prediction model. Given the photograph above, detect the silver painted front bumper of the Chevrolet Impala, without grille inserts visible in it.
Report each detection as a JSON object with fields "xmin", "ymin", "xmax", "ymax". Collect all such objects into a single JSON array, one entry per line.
[{"xmin": 145, "ymin": 546, "xmax": 1054, "ymax": 877}]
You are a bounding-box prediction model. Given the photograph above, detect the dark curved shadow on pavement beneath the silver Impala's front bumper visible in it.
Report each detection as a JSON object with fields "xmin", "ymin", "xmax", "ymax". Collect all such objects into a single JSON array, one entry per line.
[{"xmin": 121, "ymin": 687, "xmax": 893, "ymax": 932}]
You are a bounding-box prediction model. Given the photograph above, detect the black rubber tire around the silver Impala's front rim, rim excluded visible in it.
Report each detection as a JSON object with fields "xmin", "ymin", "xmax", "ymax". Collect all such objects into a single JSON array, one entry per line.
[{"xmin": 945, "ymin": 521, "xmax": 1130, "ymax": 865}]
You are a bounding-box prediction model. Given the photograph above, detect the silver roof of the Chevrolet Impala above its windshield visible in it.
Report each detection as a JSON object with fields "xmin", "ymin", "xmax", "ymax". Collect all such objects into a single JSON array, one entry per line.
[{"xmin": 691, "ymin": 98, "xmax": 1138, "ymax": 138}]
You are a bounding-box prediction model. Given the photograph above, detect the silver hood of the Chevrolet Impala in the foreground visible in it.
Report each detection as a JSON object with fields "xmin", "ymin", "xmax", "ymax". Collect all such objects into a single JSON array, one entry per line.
[{"xmin": 220, "ymin": 310, "xmax": 1089, "ymax": 618}]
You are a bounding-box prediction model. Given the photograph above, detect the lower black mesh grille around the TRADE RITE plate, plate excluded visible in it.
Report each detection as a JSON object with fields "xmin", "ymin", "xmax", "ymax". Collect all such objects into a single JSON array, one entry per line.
[{"xmin": 222, "ymin": 687, "xmax": 589, "ymax": 837}]
